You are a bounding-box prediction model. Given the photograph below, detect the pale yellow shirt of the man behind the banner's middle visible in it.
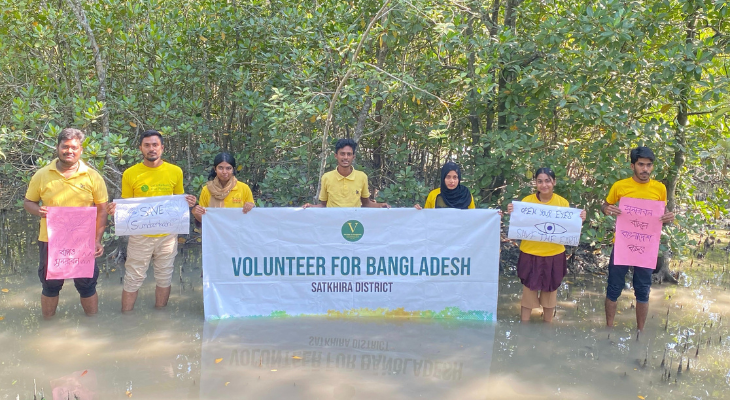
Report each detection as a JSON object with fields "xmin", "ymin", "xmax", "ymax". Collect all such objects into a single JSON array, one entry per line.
[{"xmin": 319, "ymin": 168, "xmax": 370, "ymax": 207}]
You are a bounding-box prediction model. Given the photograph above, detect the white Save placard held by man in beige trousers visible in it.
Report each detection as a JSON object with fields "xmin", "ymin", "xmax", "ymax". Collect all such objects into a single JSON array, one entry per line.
[{"xmin": 114, "ymin": 194, "xmax": 189, "ymax": 236}]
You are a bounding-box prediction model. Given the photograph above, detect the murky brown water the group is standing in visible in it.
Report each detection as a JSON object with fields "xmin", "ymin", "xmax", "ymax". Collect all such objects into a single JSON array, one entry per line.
[{"xmin": 0, "ymin": 212, "xmax": 730, "ymax": 399}]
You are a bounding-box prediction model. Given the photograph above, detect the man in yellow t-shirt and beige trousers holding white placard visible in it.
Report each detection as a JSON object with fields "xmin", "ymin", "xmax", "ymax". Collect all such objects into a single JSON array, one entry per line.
[{"xmin": 108, "ymin": 130, "xmax": 196, "ymax": 312}]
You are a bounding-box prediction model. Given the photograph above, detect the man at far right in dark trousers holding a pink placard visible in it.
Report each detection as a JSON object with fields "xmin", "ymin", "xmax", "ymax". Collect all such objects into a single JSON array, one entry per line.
[{"xmin": 601, "ymin": 147, "xmax": 674, "ymax": 332}]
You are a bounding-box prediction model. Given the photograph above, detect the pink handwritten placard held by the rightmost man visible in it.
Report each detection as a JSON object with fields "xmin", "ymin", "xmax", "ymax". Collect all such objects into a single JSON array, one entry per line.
[{"xmin": 613, "ymin": 197, "xmax": 666, "ymax": 269}]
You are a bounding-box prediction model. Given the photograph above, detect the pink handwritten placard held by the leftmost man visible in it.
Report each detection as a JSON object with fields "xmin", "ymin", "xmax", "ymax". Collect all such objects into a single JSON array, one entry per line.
[{"xmin": 46, "ymin": 207, "xmax": 96, "ymax": 279}]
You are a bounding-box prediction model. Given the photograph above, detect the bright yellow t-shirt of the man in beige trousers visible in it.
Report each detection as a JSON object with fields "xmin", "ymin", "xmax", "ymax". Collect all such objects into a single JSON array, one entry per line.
[{"xmin": 122, "ymin": 162, "xmax": 185, "ymax": 237}]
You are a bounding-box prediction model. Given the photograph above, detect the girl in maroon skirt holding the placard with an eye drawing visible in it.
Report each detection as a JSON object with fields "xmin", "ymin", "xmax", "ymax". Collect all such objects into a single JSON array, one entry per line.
[{"xmin": 507, "ymin": 168, "xmax": 586, "ymax": 322}]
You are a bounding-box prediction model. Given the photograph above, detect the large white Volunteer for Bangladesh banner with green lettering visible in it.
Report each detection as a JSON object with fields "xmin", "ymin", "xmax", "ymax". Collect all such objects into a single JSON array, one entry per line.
[{"xmin": 203, "ymin": 208, "xmax": 500, "ymax": 321}]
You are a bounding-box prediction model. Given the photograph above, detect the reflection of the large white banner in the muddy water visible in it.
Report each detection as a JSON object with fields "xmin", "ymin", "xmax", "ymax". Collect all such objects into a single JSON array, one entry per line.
[{"xmin": 200, "ymin": 317, "xmax": 495, "ymax": 399}]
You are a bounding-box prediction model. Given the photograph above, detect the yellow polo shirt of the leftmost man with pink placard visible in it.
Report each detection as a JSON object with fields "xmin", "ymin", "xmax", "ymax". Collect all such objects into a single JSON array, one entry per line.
[{"xmin": 25, "ymin": 159, "xmax": 109, "ymax": 242}]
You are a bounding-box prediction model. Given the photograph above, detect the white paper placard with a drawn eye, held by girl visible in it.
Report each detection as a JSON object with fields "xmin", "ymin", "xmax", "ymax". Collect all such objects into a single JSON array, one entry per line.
[{"xmin": 508, "ymin": 201, "xmax": 583, "ymax": 246}]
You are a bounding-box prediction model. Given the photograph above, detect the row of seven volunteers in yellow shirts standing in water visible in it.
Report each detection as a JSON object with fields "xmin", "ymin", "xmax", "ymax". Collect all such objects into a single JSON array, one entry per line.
[{"xmin": 24, "ymin": 128, "xmax": 674, "ymax": 330}]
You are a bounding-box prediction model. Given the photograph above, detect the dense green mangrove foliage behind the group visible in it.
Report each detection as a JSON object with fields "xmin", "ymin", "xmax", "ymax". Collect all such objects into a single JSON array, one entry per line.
[{"xmin": 0, "ymin": 0, "xmax": 730, "ymax": 253}]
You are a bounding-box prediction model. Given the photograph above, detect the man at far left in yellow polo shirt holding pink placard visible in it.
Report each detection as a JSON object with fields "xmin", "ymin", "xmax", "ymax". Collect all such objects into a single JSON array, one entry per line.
[{"xmin": 23, "ymin": 128, "xmax": 108, "ymax": 318}]
